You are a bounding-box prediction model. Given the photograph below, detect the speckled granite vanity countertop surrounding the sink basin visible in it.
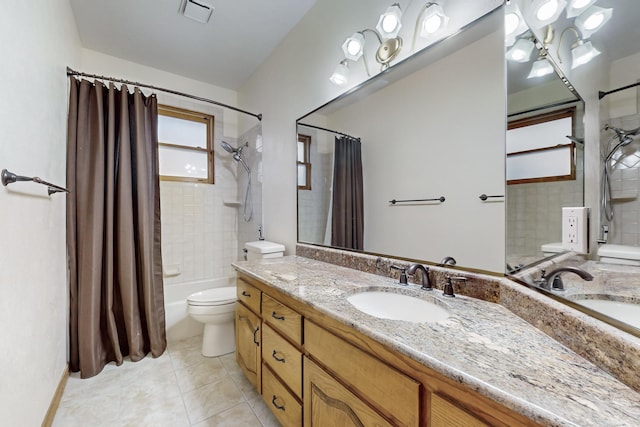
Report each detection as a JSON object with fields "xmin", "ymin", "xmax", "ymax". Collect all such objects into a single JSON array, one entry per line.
[{"xmin": 233, "ymin": 256, "xmax": 640, "ymax": 427}]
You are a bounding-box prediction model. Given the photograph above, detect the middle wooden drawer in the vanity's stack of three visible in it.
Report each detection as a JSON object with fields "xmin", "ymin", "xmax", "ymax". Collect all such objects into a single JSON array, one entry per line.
[{"xmin": 262, "ymin": 324, "xmax": 302, "ymax": 397}]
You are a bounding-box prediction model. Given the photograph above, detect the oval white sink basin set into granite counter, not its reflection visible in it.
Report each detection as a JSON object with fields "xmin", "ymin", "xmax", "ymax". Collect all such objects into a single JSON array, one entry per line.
[{"xmin": 347, "ymin": 291, "xmax": 450, "ymax": 323}]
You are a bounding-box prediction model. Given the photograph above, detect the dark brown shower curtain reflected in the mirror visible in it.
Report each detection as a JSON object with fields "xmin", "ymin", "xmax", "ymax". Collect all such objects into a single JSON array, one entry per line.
[{"xmin": 331, "ymin": 136, "xmax": 364, "ymax": 250}]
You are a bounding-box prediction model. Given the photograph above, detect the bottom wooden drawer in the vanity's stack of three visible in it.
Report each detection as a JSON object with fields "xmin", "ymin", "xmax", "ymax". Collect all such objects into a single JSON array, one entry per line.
[{"xmin": 262, "ymin": 366, "xmax": 302, "ymax": 427}]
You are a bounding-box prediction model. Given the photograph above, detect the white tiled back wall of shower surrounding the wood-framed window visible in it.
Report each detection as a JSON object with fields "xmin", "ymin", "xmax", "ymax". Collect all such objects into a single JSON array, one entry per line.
[{"xmin": 158, "ymin": 94, "xmax": 238, "ymax": 286}]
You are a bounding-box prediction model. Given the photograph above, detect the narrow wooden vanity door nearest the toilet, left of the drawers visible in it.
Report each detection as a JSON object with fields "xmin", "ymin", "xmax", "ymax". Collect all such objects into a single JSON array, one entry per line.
[{"xmin": 236, "ymin": 304, "xmax": 262, "ymax": 392}]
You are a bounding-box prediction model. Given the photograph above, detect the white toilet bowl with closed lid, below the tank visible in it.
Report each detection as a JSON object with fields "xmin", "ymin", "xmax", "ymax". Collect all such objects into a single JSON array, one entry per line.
[{"xmin": 187, "ymin": 286, "xmax": 237, "ymax": 357}]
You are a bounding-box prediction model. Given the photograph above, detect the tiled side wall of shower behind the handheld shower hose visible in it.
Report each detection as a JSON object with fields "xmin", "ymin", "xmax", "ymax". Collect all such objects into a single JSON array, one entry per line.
[{"xmin": 236, "ymin": 124, "xmax": 268, "ymax": 259}]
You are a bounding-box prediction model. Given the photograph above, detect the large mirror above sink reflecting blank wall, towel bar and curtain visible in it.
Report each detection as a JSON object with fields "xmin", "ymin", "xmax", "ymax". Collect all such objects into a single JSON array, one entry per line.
[{"xmin": 298, "ymin": 8, "xmax": 506, "ymax": 272}]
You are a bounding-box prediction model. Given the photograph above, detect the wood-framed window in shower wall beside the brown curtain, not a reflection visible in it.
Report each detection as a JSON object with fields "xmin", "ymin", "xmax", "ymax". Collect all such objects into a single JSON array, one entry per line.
[{"xmin": 158, "ymin": 105, "xmax": 214, "ymax": 184}]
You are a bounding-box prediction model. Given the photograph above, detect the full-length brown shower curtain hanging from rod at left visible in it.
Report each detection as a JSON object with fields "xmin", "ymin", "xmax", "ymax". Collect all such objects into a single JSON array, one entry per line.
[{"xmin": 67, "ymin": 77, "xmax": 166, "ymax": 378}]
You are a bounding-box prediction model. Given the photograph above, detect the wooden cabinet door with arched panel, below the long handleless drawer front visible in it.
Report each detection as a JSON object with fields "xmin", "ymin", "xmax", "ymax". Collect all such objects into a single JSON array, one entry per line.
[{"xmin": 303, "ymin": 357, "xmax": 392, "ymax": 427}]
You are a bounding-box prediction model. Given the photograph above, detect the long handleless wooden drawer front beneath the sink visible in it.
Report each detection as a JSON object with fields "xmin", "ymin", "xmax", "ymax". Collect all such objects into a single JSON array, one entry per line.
[{"xmin": 304, "ymin": 320, "xmax": 420, "ymax": 426}]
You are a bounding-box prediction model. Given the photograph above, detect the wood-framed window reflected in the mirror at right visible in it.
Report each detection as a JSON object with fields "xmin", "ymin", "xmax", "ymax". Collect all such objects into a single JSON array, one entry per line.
[{"xmin": 507, "ymin": 108, "xmax": 576, "ymax": 184}]
